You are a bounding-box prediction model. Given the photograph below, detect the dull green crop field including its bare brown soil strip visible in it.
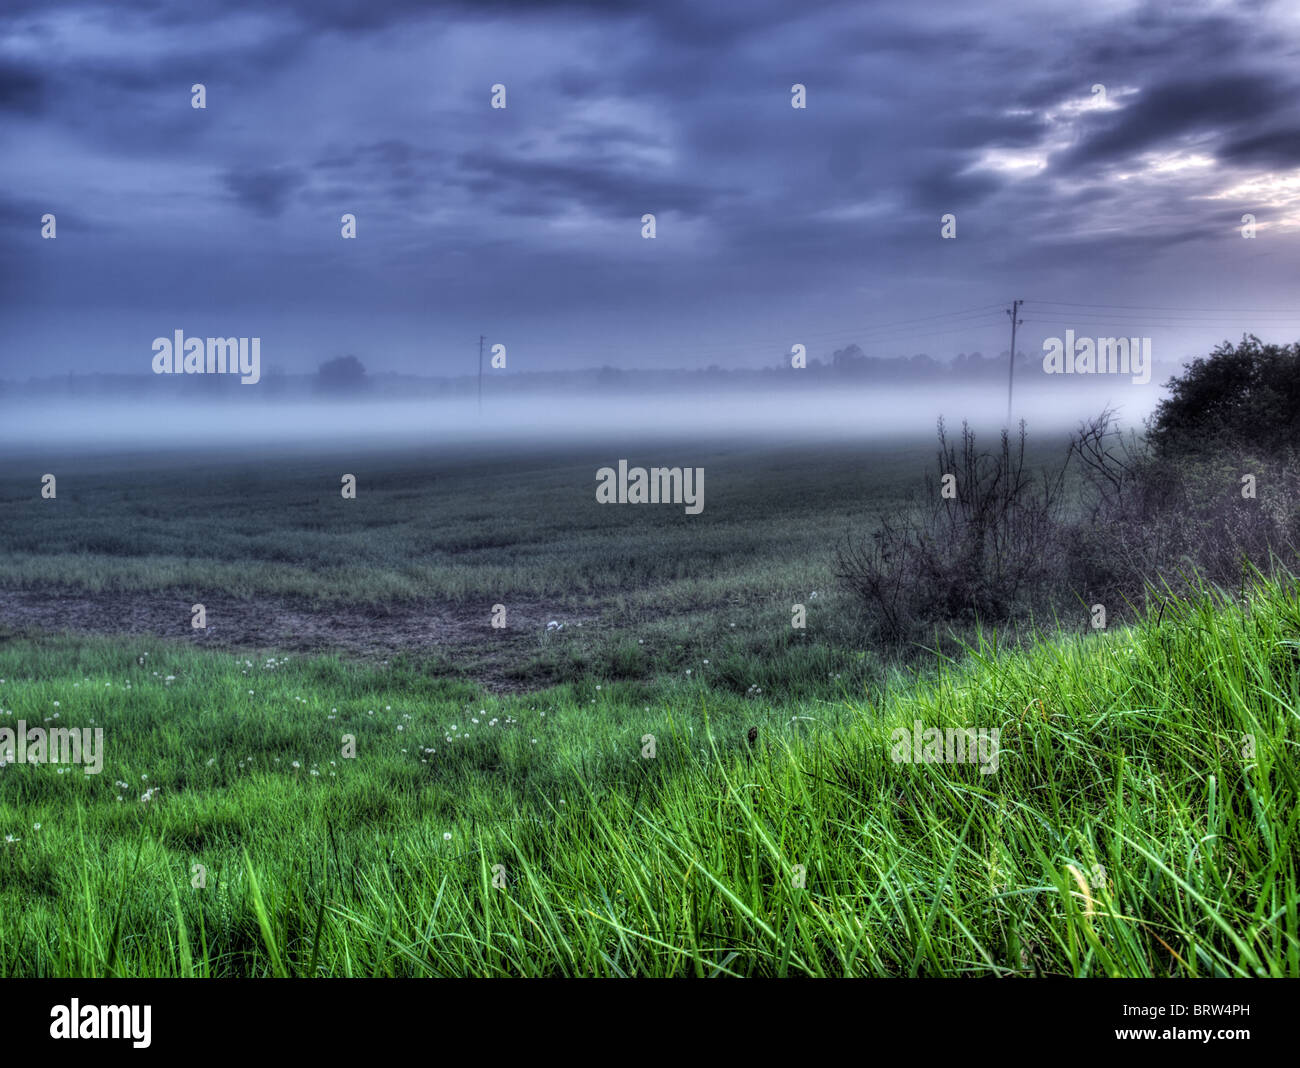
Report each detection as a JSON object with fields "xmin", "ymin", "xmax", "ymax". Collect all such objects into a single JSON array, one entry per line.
[{"xmin": 0, "ymin": 440, "xmax": 933, "ymax": 689}]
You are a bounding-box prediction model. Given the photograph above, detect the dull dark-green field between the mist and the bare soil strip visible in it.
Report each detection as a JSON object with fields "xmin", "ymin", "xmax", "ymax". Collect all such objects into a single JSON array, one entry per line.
[{"xmin": 0, "ymin": 438, "xmax": 933, "ymax": 613}]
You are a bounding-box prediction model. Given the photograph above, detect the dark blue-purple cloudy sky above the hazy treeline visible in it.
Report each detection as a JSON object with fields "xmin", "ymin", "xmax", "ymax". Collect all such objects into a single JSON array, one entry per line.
[{"xmin": 0, "ymin": 0, "xmax": 1300, "ymax": 378}]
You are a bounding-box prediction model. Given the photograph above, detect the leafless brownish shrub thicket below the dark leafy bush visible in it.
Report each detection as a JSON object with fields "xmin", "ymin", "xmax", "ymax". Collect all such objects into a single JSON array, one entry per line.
[{"xmin": 836, "ymin": 409, "xmax": 1300, "ymax": 641}]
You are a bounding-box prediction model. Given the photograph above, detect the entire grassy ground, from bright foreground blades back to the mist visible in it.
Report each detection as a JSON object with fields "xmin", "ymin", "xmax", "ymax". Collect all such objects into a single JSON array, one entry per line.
[{"xmin": 0, "ymin": 444, "xmax": 1300, "ymax": 976}]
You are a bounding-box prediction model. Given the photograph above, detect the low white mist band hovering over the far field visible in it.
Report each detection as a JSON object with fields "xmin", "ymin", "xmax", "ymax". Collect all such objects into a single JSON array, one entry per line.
[{"xmin": 0, "ymin": 381, "xmax": 1158, "ymax": 455}]
